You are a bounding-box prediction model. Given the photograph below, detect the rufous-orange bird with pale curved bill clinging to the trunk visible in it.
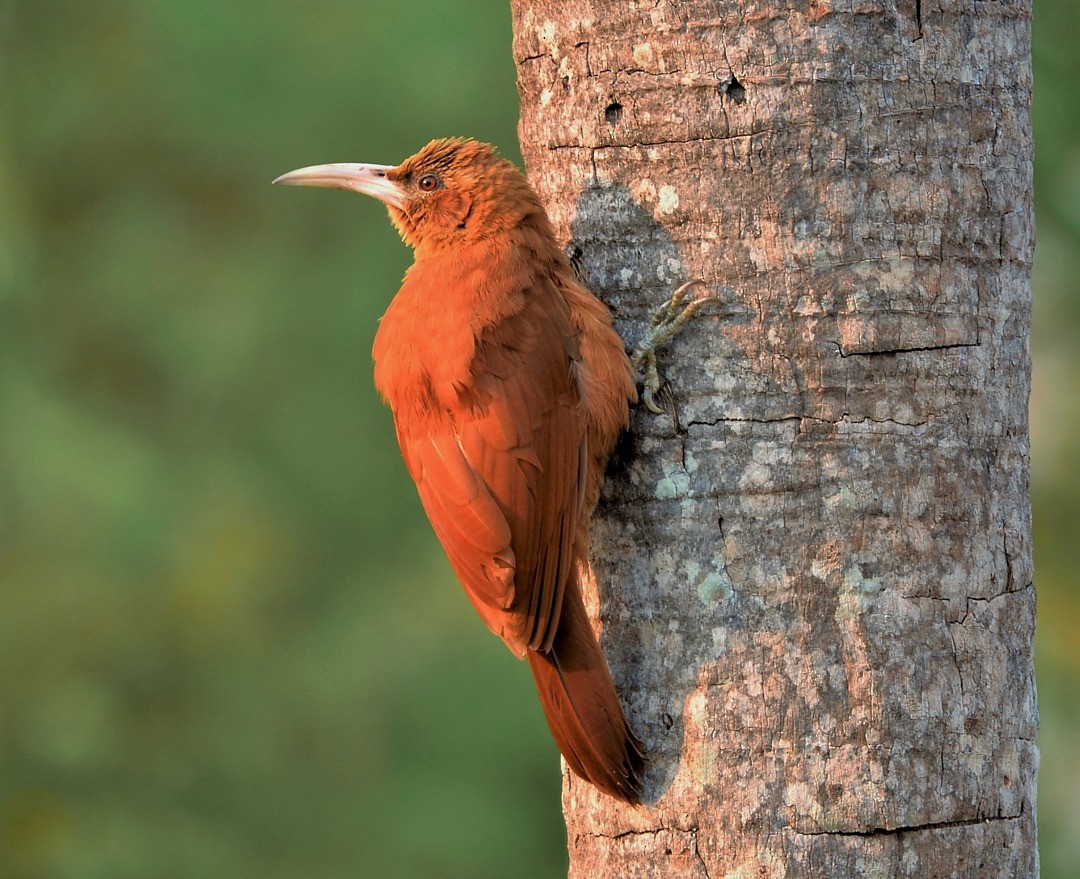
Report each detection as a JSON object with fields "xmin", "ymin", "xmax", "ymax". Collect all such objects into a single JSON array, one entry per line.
[{"xmin": 274, "ymin": 137, "xmax": 717, "ymax": 804}]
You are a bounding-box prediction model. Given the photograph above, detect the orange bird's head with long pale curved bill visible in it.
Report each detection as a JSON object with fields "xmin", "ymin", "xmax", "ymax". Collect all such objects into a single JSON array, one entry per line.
[{"xmin": 274, "ymin": 138, "xmax": 543, "ymax": 253}]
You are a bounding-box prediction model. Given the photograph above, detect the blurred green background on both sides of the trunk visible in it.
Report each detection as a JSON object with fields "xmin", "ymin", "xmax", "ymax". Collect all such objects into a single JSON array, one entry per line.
[{"xmin": 0, "ymin": 0, "xmax": 1080, "ymax": 879}]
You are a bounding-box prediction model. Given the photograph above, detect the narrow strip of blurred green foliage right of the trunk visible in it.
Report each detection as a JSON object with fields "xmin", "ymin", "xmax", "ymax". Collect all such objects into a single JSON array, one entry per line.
[{"xmin": 1031, "ymin": 0, "xmax": 1080, "ymax": 879}]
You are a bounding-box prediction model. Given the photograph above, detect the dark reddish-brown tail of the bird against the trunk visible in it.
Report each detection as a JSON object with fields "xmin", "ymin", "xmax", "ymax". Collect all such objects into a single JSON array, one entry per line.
[{"xmin": 528, "ymin": 573, "xmax": 645, "ymax": 803}]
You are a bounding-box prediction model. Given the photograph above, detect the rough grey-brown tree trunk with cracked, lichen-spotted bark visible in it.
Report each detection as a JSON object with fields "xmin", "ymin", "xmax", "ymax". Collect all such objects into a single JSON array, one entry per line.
[{"xmin": 513, "ymin": 0, "xmax": 1038, "ymax": 879}]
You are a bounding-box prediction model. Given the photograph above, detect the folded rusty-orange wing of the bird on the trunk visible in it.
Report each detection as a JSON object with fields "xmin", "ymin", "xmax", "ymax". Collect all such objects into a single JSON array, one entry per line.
[{"xmin": 397, "ymin": 280, "xmax": 588, "ymax": 655}]
